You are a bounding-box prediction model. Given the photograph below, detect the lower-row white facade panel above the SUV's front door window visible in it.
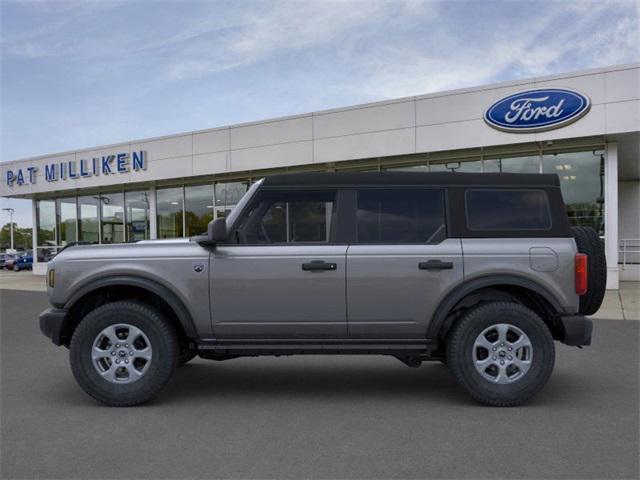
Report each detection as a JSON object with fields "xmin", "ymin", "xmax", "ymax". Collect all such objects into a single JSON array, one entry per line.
[{"xmin": 231, "ymin": 141, "xmax": 313, "ymax": 172}]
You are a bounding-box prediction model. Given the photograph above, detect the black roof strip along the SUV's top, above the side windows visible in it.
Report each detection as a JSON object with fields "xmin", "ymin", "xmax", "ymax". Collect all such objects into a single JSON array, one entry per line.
[{"xmin": 263, "ymin": 171, "xmax": 560, "ymax": 187}]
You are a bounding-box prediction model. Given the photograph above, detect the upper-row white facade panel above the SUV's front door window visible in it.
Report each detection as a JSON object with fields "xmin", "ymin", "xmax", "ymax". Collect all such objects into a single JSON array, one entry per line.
[{"xmin": 230, "ymin": 115, "xmax": 313, "ymax": 150}]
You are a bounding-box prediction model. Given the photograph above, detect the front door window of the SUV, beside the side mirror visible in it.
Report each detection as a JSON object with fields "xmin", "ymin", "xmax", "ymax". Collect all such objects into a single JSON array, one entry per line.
[{"xmin": 237, "ymin": 191, "xmax": 335, "ymax": 244}]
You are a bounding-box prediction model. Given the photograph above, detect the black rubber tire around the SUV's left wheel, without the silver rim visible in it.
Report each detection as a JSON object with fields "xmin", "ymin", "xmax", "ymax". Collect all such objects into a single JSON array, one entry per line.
[{"xmin": 69, "ymin": 301, "xmax": 178, "ymax": 407}]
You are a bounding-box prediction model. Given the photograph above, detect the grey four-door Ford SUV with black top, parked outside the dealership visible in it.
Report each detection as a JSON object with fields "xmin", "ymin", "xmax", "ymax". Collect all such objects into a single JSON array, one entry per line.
[{"xmin": 40, "ymin": 172, "xmax": 606, "ymax": 406}]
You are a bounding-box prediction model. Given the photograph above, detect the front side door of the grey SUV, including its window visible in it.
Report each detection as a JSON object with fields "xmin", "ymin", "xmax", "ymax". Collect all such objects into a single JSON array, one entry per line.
[{"xmin": 210, "ymin": 189, "xmax": 347, "ymax": 340}]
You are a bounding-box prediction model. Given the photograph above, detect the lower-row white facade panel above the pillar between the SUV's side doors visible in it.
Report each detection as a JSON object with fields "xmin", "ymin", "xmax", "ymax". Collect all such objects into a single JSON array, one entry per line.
[{"xmin": 314, "ymin": 128, "xmax": 415, "ymax": 163}]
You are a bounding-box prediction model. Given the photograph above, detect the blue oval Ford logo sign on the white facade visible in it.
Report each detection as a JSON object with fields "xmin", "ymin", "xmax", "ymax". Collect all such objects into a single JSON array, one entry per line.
[{"xmin": 484, "ymin": 88, "xmax": 591, "ymax": 133}]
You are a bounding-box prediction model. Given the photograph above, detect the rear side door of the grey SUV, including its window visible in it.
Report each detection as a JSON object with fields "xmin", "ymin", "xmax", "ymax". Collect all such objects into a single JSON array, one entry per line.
[{"xmin": 347, "ymin": 187, "xmax": 463, "ymax": 339}]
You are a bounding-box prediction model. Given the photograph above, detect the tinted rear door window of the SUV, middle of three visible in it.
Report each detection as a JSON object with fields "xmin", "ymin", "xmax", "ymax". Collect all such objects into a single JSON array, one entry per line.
[{"xmin": 357, "ymin": 188, "xmax": 446, "ymax": 243}]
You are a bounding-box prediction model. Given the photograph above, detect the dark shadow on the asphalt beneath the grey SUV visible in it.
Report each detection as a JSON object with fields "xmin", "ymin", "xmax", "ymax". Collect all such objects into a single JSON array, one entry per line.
[{"xmin": 146, "ymin": 357, "xmax": 580, "ymax": 405}]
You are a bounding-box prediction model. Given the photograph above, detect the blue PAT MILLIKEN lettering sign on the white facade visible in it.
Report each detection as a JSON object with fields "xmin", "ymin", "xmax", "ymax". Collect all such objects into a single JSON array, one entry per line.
[{"xmin": 4, "ymin": 150, "xmax": 147, "ymax": 187}]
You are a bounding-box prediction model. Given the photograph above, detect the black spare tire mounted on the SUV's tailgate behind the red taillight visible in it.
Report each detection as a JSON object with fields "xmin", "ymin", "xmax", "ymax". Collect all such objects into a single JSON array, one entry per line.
[{"xmin": 572, "ymin": 227, "xmax": 607, "ymax": 315}]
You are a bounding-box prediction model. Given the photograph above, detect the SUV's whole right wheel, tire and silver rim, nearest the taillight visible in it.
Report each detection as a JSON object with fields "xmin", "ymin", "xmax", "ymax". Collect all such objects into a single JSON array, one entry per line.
[{"xmin": 446, "ymin": 302, "xmax": 555, "ymax": 407}]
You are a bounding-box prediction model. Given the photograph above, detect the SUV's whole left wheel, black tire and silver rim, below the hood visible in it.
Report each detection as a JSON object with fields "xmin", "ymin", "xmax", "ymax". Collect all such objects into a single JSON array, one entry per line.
[{"xmin": 70, "ymin": 301, "xmax": 178, "ymax": 407}]
